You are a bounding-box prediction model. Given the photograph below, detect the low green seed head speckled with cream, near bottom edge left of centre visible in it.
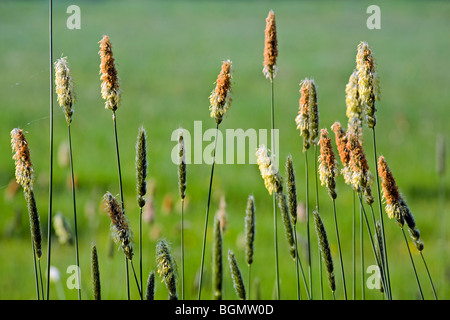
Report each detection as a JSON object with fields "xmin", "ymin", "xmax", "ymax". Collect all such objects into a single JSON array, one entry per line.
[{"xmin": 156, "ymin": 239, "xmax": 178, "ymax": 300}]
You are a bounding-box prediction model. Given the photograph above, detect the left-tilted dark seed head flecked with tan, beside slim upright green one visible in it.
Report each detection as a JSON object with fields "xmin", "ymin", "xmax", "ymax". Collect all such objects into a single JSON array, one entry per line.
[{"xmin": 103, "ymin": 192, "xmax": 133, "ymax": 260}]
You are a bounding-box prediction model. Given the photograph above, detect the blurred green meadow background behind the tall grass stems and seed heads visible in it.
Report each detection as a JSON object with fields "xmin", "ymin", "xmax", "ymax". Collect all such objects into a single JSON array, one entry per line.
[{"xmin": 0, "ymin": 1, "xmax": 450, "ymax": 299}]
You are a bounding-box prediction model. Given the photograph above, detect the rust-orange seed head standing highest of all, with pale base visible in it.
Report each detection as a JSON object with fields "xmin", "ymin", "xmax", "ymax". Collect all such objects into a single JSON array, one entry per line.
[{"xmin": 263, "ymin": 10, "xmax": 278, "ymax": 81}]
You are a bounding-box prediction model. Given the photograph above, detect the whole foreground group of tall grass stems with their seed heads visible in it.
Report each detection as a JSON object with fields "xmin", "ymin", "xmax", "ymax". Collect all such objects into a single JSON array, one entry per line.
[{"xmin": 11, "ymin": 6, "xmax": 443, "ymax": 300}]
